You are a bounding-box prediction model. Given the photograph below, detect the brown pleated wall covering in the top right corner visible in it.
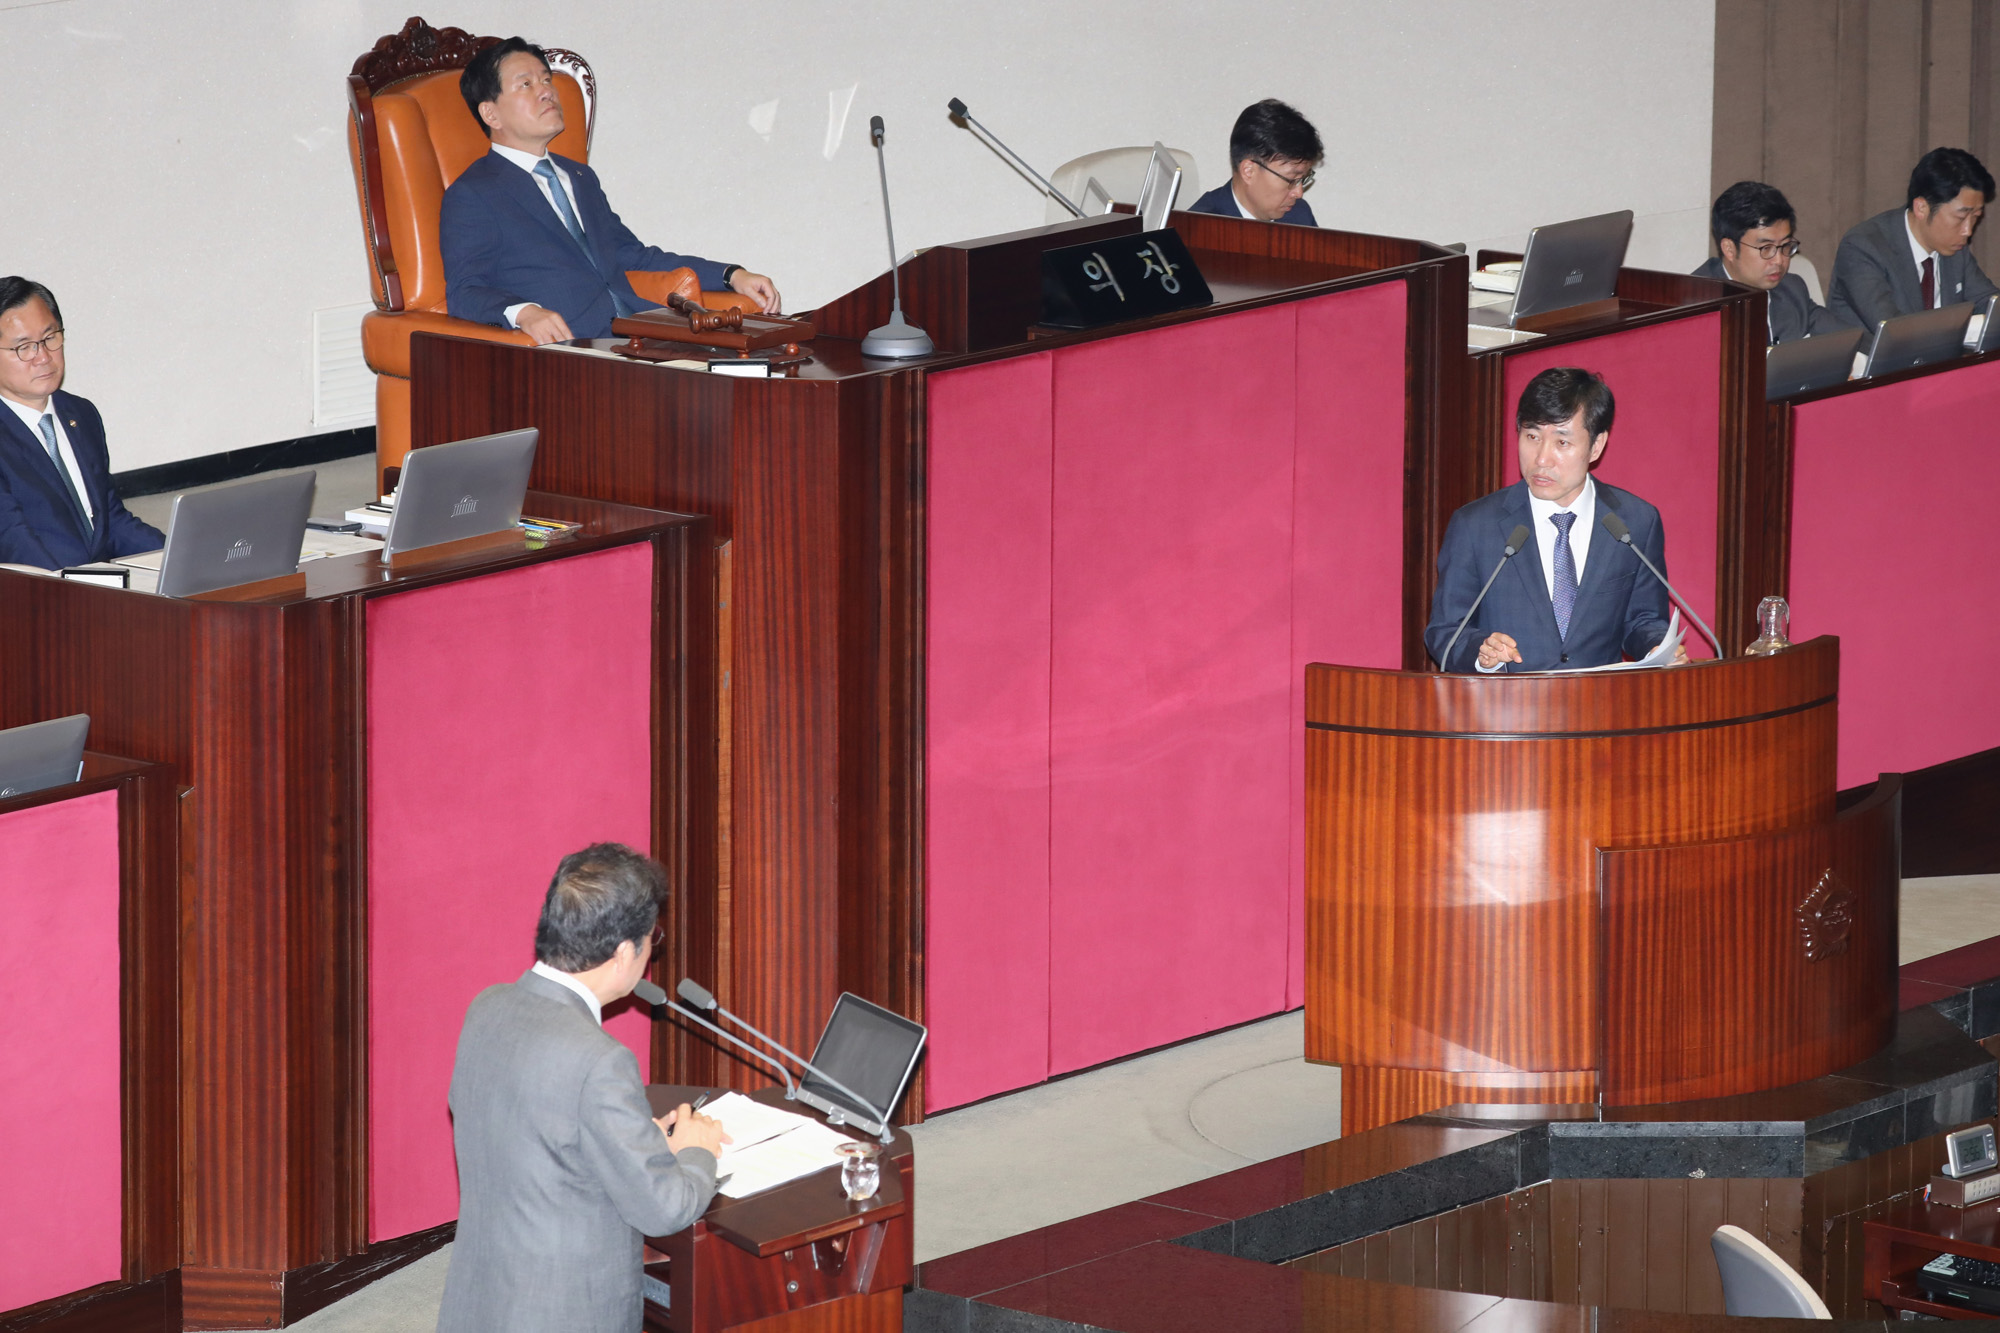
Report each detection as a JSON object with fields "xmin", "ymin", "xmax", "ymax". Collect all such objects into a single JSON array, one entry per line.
[{"xmin": 1710, "ymin": 0, "xmax": 2000, "ymax": 282}]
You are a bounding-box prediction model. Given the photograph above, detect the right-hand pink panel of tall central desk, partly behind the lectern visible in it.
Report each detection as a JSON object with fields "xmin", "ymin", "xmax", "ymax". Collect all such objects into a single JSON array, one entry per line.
[{"xmin": 1284, "ymin": 282, "xmax": 1410, "ymax": 1009}]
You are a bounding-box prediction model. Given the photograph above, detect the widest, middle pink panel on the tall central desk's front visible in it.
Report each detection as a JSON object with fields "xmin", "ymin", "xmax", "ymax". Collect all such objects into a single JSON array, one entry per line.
[{"xmin": 1050, "ymin": 304, "xmax": 1296, "ymax": 1073}]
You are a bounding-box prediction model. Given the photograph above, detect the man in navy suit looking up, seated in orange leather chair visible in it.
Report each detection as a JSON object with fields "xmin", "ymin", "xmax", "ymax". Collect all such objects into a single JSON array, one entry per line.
[{"xmin": 438, "ymin": 36, "xmax": 778, "ymax": 346}]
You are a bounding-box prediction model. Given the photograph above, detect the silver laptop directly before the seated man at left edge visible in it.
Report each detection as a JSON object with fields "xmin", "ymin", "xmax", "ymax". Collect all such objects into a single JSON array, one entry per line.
[{"xmin": 158, "ymin": 470, "xmax": 320, "ymax": 596}]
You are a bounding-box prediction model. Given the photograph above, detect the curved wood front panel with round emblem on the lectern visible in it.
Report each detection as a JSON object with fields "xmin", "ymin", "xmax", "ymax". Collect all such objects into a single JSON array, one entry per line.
[{"xmin": 1598, "ymin": 775, "xmax": 1902, "ymax": 1107}]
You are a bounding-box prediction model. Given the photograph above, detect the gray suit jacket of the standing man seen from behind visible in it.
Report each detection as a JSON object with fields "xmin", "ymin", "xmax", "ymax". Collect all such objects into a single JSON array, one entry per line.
[{"xmin": 438, "ymin": 971, "xmax": 716, "ymax": 1333}]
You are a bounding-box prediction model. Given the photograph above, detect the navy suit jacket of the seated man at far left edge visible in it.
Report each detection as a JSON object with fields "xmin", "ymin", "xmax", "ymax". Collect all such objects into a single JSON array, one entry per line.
[{"xmin": 0, "ymin": 388, "xmax": 166, "ymax": 568}]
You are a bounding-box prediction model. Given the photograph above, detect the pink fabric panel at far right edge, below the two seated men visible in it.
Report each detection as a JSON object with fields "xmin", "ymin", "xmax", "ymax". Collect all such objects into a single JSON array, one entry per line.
[{"xmin": 1790, "ymin": 364, "xmax": 2000, "ymax": 787}]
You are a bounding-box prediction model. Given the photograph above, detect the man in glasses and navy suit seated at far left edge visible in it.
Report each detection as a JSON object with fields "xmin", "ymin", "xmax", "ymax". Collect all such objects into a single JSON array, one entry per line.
[{"xmin": 0, "ymin": 278, "xmax": 166, "ymax": 568}]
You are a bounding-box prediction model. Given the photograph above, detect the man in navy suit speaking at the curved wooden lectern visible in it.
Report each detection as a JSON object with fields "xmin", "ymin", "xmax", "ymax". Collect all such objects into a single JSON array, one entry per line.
[{"xmin": 1424, "ymin": 368, "xmax": 1688, "ymax": 673}]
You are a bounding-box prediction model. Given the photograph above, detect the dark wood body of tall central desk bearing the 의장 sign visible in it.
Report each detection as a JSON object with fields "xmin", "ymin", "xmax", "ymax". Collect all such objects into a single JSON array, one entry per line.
[{"xmin": 412, "ymin": 218, "xmax": 1464, "ymax": 1119}]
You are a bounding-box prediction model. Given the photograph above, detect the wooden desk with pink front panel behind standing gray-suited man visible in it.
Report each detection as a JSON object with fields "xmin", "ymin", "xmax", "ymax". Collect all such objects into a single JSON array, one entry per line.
[{"xmin": 0, "ymin": 492, "xmax": 714, "ymax": 1329}]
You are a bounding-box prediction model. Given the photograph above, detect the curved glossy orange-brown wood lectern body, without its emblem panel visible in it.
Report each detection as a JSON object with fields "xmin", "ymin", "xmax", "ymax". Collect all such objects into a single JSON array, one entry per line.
[{"xmin": 1306, "ymin": 638, "xmax": 1838, "ymax": 1133}]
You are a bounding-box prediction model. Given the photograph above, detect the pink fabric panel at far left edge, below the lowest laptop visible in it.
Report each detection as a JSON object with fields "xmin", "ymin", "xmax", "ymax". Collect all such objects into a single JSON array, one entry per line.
[{"xmin": 0, "ymin": 791, "xmax": 124, "ymax": 1309}]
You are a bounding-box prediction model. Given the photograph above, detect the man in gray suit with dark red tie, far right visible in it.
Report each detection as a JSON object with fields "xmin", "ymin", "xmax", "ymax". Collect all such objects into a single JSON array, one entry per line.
[{"xmin": 1826, "ymin": 148, "xmax": 1996, "ymax": 330}]
